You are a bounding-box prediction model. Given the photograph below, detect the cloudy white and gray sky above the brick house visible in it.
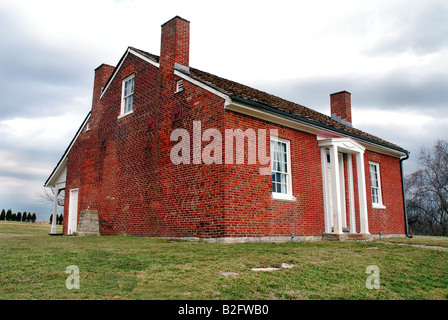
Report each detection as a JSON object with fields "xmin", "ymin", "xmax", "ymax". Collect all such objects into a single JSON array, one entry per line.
[{"xmin": 0, "ymin": 0, "xmax": 448, "ymax": 220}]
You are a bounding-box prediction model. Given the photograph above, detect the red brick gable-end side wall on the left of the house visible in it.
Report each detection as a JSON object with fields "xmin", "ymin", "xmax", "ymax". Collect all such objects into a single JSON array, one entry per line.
[{"xmin": 65, "ymin": 54, "xmax": 228, "ymax": 237}]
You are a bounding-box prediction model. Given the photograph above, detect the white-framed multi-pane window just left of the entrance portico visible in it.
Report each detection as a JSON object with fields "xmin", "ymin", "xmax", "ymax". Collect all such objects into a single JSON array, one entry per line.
[{"xmin": 270, "ymin": 136, "xmax": 295, "ymax": 200}]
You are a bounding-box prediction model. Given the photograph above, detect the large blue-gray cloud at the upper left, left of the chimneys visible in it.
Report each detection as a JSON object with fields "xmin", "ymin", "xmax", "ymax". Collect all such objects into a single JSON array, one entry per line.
[{"xmin": 0, "ymin": 5, "xmax": 93, "ymax": 120}]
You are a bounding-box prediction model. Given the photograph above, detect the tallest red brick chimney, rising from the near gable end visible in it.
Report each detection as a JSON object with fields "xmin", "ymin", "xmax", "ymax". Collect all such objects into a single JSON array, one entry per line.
[{"xmin": 160, "ymin": 16, "xmax": 190, "ymax": 69}]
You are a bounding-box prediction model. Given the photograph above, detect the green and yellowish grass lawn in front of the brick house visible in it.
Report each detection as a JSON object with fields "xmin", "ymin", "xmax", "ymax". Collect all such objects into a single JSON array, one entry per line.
[{"xmin": 0, "ymin": 222, "xmax": 448, "ymax": 300}]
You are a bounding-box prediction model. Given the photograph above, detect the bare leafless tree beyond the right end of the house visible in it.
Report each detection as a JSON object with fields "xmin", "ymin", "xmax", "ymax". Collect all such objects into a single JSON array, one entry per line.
[{"xmin": 405, "ymin": 140, "xmax": 448, "ymax": 236}]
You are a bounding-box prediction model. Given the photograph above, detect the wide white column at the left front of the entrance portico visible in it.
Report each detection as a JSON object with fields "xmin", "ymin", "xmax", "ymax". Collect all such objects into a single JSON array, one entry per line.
[{"xmin": 330, "ymin": 145, "xmax": 342, "ymax": 234}]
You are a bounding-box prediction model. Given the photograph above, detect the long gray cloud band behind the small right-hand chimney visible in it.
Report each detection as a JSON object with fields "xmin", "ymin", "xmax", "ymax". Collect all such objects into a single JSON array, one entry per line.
[{"xmin": 254, "ymin": 65, "xmax": 448, "ymax": 113}]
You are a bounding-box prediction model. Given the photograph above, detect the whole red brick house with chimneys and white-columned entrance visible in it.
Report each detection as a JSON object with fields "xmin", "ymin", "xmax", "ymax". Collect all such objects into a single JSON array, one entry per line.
[{"xmin": 45, "ymin": 17, "xmax": 408, "ymax": 242}]
